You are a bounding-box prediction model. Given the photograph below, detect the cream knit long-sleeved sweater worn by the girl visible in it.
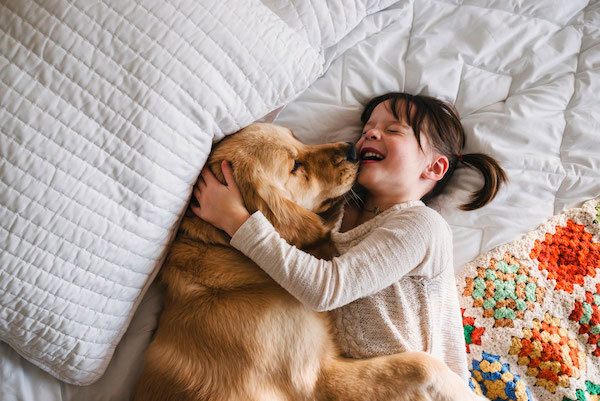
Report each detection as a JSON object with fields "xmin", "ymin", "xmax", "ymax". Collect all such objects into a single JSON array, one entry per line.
[{"xmin": 231, "ymin": 201, "xmax": 469, "ymax": 382}]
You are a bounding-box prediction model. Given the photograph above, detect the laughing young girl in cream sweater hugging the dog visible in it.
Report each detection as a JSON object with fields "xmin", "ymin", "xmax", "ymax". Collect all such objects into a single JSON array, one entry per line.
[{"xmin": 192, "ymin": 93, "xmax": 506, "ymax": 381}]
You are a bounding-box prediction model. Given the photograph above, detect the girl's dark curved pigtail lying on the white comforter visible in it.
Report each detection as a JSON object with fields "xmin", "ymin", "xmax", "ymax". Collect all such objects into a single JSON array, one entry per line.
[{"xmin": 460, "ymin": 153, "xmax": 508, "ymax": 210}]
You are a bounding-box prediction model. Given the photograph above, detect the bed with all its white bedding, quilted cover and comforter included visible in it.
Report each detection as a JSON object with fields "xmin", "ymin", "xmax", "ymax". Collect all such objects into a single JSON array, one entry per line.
[{"xmin": 0, "ymin": 0, "xmax": 600, "ymax": 401}]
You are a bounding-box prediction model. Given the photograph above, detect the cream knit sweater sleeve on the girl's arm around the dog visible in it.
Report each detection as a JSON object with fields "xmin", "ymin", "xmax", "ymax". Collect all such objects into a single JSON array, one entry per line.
[{"xmin": 231, "ymin": 207, "xmax": 445, "ymax": 311}]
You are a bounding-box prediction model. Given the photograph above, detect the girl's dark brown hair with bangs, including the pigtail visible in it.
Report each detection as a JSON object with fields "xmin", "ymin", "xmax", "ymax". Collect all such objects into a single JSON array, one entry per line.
[{"xmin": 360, "ymin": 92, "xmax": 508, "ymax": 210}]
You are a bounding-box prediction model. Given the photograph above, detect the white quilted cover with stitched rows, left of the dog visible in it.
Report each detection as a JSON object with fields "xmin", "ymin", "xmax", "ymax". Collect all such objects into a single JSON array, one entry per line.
[{"xmin": 0, "ymin": 0, "xmax": 390, "ymax": 384}]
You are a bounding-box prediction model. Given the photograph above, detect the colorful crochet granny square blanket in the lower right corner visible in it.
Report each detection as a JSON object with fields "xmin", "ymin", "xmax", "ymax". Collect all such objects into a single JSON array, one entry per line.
[{"xmin": 457, "ymin": 197, "xmax": 600, "ymax": 401}]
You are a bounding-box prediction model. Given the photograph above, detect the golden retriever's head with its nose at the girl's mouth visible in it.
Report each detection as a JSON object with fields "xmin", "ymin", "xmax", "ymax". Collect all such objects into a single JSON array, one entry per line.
[{"xmin": 185, "ymin": 124, "xmax": 358, "ymax": 246}]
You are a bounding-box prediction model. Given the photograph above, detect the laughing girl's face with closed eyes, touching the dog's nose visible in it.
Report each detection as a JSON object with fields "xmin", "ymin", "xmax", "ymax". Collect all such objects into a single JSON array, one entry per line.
[{"xmin": 356, "ymin": 100, "xmax": 433, "ymax": 200}]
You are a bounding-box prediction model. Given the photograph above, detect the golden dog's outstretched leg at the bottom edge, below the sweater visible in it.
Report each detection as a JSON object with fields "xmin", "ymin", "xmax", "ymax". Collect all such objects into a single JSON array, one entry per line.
[{"xmin": 316, "ymin": 352, "xmax": 479, "ymax": 401}]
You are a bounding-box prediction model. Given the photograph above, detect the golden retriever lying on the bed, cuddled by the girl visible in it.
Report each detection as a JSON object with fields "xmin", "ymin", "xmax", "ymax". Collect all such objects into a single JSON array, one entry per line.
[{"xmin": 135, "ymin": 124, "xmax": 475, "ymax": 401}]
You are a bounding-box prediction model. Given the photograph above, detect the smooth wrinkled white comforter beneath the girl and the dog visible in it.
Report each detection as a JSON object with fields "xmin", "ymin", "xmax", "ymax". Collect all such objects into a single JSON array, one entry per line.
[{"xmin": 0, "ymin": 0, "xmax": 600, "ymax": 400}]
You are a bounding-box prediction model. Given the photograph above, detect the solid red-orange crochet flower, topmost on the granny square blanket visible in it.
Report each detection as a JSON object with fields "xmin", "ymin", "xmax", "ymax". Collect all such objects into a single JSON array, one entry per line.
[{"xmin": 529, "ymin": 220, "xmax": 600, "ymax": 294}]
